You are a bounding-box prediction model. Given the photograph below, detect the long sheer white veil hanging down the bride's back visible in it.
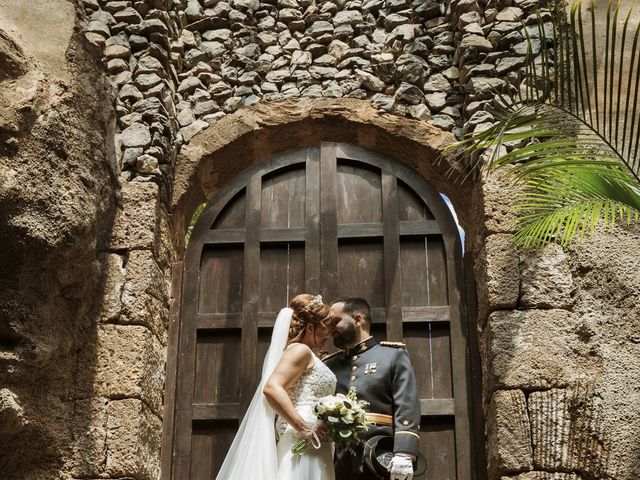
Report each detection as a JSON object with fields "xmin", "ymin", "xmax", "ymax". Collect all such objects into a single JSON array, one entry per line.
[{"xmin": 216, "ymin": 308, "xmax": 293, "ymax": 480}]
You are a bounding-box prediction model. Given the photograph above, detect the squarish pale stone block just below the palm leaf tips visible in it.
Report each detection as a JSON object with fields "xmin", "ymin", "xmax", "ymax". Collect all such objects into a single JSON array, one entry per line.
[{"xmin": 520, "ymin": 244, "xmax": 573, "ymax": 308}]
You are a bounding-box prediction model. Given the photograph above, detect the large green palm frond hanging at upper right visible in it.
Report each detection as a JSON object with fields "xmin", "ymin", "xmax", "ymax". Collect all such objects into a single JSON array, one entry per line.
[{"xmin": 451, "ymin": 1, "xmax": 640, "ymax": 247}]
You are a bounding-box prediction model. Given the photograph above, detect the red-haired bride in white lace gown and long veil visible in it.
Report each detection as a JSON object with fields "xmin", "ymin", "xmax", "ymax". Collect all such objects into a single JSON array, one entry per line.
[{"xmin": 216, "ymin": 294, "xmax": 336, "ymax": 480}]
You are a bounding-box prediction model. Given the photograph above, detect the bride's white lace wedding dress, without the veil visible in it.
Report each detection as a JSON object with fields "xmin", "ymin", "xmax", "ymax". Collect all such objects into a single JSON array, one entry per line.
[{"xmin": 277, "ymin": 348, "xmax": 336, "ymax": 480}]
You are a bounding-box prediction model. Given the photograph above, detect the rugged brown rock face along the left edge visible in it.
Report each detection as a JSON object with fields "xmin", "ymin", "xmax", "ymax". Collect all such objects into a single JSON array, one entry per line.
[{"xmin": 0, "ymin": 0, "xmax": 117, "ymax": 480}]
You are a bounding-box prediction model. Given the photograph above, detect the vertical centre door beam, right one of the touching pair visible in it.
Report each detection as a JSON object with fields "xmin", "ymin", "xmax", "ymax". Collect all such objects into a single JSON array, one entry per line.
[{"xmin": 320, "ymin": 143, "xmax": 345, "ymax": 301}]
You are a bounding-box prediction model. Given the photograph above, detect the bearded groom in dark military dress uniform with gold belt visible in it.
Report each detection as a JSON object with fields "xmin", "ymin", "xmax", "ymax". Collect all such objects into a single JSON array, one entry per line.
[{"xmin": 324, "ymin": 297, "xmax": 420, "ymax": 480}]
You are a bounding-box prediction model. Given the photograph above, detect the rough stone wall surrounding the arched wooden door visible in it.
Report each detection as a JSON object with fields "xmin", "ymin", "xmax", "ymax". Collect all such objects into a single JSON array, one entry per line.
[{"xmin": 0, "ymin": 0, "xmax": 640, "ymax": 480}]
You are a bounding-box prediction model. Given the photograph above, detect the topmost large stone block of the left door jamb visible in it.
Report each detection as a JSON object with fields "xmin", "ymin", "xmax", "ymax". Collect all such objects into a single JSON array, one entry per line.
[{"xmin": 110, "ymin": 182, "xmax": 159, "ymax": 250}]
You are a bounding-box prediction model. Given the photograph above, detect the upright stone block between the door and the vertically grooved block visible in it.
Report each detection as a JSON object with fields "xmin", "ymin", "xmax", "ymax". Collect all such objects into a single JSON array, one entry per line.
[{"xmin": 487, "ymin": 390, "xmax": 533, "ymax": 478}]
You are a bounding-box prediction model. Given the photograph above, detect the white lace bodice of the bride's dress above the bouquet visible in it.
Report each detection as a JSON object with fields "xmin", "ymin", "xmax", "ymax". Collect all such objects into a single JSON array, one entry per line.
[{"xmin": 287, "ymin": 354, "xmax": 336, "ymax": 411}]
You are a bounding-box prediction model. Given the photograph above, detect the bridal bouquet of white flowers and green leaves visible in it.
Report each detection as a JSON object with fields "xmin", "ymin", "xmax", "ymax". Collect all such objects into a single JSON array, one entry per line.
[{"xmin": 291, "ymin": 387, "xmax": 369, "ymax": 455}]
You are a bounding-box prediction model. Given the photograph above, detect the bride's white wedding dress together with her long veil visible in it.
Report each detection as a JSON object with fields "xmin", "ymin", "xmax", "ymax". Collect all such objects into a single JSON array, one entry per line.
[{"xmin": 216, "ymin": 308, "xmax": 336, "ymax": 480}]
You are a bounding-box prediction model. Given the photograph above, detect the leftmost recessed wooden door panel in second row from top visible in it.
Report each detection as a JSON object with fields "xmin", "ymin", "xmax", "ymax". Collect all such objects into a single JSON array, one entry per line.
[{"xmin": 198, "ymin": 245, "xmax": 246, "ymax": 313}]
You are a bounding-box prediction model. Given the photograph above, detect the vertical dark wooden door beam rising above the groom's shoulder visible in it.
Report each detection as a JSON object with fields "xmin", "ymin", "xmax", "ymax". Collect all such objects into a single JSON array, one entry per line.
[{"xmin": 382, "ymin": 172, "xmax": 402, "ymax": 342}]
